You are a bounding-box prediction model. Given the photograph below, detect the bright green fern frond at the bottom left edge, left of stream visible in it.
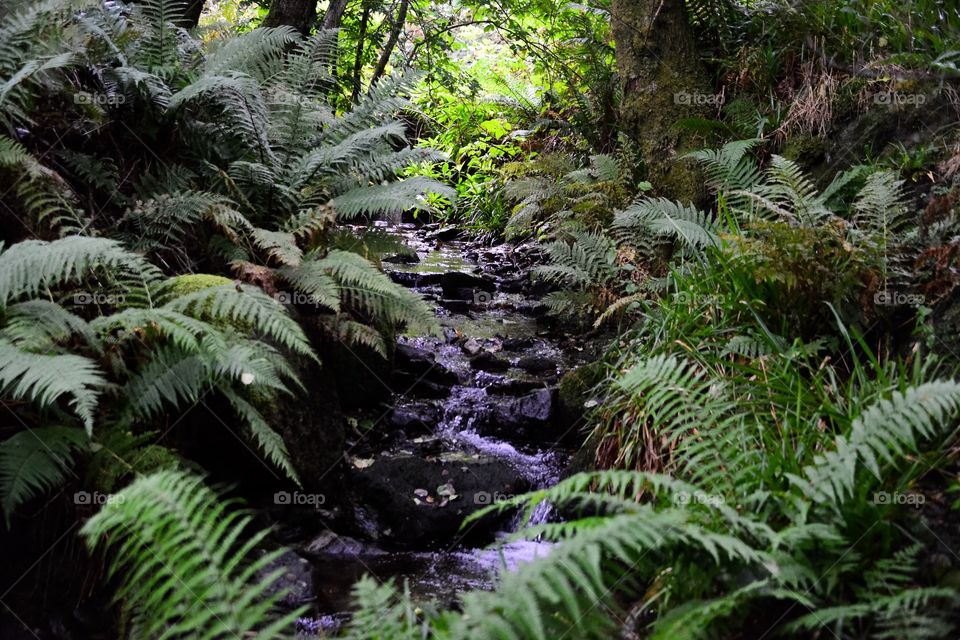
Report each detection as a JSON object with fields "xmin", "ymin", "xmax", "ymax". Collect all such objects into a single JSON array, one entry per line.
[{"xmin": 81, "ymin": 471, "xmax": 303, "ymax": 638}]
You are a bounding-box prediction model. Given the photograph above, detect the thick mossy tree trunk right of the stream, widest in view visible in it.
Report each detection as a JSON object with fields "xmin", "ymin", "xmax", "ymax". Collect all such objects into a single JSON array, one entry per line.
[{"xmin": 610, "ymin": 0, "xmax": 713, "ymax": 203}]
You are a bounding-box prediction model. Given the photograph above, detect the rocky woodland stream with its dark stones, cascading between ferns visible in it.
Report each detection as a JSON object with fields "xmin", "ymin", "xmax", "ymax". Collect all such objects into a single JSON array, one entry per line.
[{"xmin": 274, "ymin": 224, "xmax": 584, "ymax": 637}]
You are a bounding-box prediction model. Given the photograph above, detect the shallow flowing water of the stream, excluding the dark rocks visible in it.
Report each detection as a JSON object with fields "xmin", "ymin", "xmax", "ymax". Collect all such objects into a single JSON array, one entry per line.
[{"xmin": 301, "ymin": 225, "xmax": 570, "ymax": 637}]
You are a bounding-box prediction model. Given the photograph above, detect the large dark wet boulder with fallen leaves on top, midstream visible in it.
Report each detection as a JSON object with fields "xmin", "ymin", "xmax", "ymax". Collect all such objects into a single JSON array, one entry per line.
[{"xmin": 351, "ymin": 454, "xmax": 529, "ymax": 545}]
